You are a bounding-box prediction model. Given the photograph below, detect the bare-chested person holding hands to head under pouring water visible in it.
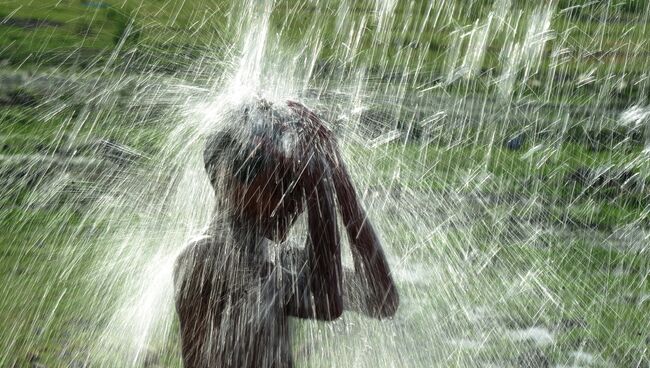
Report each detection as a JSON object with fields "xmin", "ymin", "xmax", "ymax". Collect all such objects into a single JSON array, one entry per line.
[{"xmin": 174, "ymin": 98, "xmax": 399, "ymax": 368}]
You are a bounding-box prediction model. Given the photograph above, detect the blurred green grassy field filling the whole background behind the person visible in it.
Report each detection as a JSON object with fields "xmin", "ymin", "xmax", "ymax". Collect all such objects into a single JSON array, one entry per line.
[{"xmin": 0, "ymin": 0, "xmax": 650, "ymax": 368}]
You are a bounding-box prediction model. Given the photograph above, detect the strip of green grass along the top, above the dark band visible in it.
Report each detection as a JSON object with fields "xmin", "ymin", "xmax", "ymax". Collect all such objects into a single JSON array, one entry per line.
[{"xmin": 0, "ymin": 0, "xmax": 650, "ymax": 82}]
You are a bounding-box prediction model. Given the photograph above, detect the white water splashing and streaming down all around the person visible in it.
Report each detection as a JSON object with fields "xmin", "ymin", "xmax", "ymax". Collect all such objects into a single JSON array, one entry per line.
[{"xmin": 0, "ymin": 0, "xmax": 650, "ymax": 367}]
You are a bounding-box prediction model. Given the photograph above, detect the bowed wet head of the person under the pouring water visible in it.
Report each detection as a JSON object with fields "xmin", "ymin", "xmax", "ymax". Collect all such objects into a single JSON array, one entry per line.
[{"xmin": 204, "ymin": 99, "xmax": 313, "ymax": 240}]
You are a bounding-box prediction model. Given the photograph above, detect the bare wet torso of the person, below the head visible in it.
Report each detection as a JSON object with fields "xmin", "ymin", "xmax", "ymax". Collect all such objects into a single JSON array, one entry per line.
[{"xmin": 174, "ymin": 237, "xmax": 292, "ymax": 368}]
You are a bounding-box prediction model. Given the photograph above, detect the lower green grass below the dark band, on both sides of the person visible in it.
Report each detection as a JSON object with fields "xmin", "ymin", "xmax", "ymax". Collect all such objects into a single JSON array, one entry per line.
[{"xmin": 0, "ymin": 100, "xmax": 650, "ymax": 367}]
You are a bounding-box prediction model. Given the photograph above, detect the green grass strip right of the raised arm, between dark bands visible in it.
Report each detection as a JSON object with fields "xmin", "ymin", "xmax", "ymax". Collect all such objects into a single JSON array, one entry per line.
[{"xmin": 351, "ymin": 135, "xmax": 650, "ymax": 230}]
